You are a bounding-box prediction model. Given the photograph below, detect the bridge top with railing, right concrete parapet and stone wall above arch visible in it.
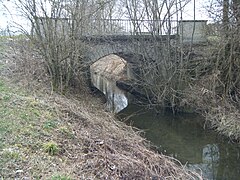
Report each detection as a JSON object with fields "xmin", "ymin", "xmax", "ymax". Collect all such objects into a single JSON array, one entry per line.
[{"xmin": 81, "ymin": 19, "xmax": 206, "ymax": 72}]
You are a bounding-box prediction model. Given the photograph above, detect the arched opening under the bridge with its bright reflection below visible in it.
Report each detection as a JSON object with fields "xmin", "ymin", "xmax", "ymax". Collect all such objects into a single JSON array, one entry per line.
[{"xmin": 90, "ymin": 54, "xmax": 128, "ymax": 113}]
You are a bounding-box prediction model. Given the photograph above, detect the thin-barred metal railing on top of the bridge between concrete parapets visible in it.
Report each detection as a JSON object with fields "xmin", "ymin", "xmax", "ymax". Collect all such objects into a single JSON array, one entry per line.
[{"xmin": 82, "ymin": 19, "xmax": 178, "ymax": 35}]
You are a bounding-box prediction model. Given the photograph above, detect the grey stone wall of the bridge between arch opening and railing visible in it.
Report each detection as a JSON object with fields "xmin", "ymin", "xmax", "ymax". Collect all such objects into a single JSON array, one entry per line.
[{"xmin": 81, "ymin": 35, "xmax": 178, "ymax": 63}]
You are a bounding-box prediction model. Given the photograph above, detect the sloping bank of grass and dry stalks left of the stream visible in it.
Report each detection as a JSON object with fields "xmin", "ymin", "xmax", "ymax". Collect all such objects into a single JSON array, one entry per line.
[{"xmin": 0, "ymin": 37, "xmax": 201, "ymax": 180}]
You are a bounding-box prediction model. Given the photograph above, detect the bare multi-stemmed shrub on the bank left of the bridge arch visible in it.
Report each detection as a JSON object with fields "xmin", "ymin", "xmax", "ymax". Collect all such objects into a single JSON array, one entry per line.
[{"xmin": 12, "ymin": 0, "xmax": 119, "ymax": 92}]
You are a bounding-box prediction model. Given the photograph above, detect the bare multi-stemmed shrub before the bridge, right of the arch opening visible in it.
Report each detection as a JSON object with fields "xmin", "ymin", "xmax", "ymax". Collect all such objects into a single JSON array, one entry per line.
[{"xmin": 120, "ymin": 0, "xmax": 195, "ymax": 111}]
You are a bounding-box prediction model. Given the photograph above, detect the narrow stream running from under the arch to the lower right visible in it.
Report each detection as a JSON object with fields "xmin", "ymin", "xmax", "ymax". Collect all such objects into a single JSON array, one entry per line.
[{"xmin": 91, "ymin": 62, "xmax": 240, "ymax": 180}]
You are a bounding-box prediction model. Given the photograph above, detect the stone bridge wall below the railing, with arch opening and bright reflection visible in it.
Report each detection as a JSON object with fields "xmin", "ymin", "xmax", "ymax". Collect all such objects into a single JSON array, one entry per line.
[{"xmin": 86, "ymin": 35, "xmax": 178, "ymax": 113}]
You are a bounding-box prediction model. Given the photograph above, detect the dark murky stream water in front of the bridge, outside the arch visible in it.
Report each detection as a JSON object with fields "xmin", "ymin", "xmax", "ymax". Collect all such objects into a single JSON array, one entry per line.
[{"xmin": 119, "ymin": 105, "xmax": 240, "ymax": 180}]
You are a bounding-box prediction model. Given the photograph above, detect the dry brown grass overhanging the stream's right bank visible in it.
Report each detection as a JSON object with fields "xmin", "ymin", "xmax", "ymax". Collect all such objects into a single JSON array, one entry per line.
[{"xmin": 185, "ymin": 74, "xmax": 240, "ymax": 142}]
